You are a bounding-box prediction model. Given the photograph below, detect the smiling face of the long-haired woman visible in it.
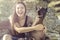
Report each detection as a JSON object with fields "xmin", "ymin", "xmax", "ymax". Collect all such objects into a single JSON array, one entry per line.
[{"xmin": 16, "ymin": 4, "xmax": 26, "ymax": 17}]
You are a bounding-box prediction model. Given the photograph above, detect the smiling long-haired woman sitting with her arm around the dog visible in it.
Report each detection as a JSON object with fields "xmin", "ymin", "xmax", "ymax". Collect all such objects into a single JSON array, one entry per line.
[{"xmin": 3, "ymin": 2, "xmax": 44, "ymax": 40}]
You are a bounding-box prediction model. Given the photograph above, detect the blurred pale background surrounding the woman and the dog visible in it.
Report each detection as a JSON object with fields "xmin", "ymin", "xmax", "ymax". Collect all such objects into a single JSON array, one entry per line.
[{"xmin": 0, "ymin": 0, "xmax": 60, "ymax": 40}]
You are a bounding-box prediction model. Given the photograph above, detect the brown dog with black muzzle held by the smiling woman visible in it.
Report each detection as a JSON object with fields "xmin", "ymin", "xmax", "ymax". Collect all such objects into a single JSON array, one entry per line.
[{"xmin": 31, "ymin": 8, "xmax": 47, "ymax": 40}]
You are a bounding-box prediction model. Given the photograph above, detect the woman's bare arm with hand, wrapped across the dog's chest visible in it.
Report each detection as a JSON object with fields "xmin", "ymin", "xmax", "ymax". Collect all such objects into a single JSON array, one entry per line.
[{"xmin": 14, "ymin": 24, "xmax": 43, "ymax": 33}]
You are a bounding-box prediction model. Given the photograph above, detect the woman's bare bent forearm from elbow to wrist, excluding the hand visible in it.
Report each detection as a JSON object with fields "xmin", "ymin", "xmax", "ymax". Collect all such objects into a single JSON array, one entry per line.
[{"xmin": 14, "ymin": 23, "xmax": 35, "ymax": 33}]
